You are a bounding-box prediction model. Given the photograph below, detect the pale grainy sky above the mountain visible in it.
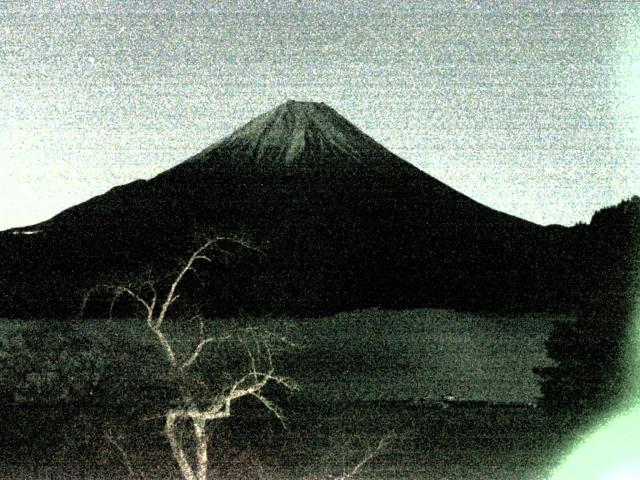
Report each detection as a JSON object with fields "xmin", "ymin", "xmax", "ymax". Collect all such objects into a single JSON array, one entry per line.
[{"xmin": 0, "ymin": 0, "xmax": 640, "ymax": 229}]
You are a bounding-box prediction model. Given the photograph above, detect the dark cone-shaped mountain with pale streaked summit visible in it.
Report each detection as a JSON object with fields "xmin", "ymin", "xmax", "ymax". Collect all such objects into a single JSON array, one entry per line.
[{"xmin": 0, "ymin": 101, "xmax": 577, "ymax": 317}]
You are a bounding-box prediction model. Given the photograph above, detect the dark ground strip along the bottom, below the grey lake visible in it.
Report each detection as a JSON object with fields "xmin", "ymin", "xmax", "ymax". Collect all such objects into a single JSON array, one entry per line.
[{"xmin": 0, "ymin": 401, "xmax": 570, "ymax": 480}]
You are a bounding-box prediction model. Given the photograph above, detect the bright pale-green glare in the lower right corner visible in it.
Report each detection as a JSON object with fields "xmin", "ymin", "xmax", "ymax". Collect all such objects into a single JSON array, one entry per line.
[{"xmin": 549, "ymin": 303, "xmax": 640, "ymax": 480}]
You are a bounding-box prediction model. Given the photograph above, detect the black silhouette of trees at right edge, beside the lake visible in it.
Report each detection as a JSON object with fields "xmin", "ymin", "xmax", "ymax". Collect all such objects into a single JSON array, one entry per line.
[{"xmin": 536, "ymin": 196, "xmax": 640, "ymax": 416}]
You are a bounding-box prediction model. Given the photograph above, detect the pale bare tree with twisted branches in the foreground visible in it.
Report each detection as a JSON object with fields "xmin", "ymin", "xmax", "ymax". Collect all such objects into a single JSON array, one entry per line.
[{"xmin": 83, "ymin": 237, "xmax": 296, "ymax": 480}]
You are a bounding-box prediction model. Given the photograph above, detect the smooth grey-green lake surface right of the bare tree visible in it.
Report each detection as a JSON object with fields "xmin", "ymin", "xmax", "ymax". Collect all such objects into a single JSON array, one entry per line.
[{"xmin": 268, "ymin": 309, "xmax": 568, "ymax": 402}]
